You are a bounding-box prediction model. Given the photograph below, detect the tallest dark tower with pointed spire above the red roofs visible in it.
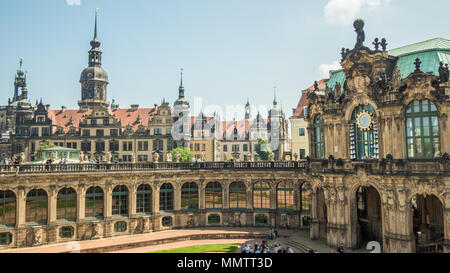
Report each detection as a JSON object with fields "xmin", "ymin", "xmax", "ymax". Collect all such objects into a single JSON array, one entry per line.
[{"xmin": 78, "ymin": 10, "xmax": 109, "ymax": 108}]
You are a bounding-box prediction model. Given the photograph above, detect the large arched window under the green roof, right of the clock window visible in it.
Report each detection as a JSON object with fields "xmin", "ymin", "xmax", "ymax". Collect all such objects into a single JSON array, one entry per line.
[{"xmin": 406, "ymin": 100, "xmax": 441, "ymax": 158}]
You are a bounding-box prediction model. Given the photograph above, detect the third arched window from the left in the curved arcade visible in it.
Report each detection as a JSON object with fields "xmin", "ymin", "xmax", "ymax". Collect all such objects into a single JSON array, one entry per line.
[{"xmin": 56, "ymin": 188, "xmax": 77, "ymax": 221}]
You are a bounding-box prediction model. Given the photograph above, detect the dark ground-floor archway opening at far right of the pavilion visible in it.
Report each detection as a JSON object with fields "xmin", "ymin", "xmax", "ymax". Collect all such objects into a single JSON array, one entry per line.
[{"xmin": 411, "ymin": 195, "xmax": 444, "ymax": 253}]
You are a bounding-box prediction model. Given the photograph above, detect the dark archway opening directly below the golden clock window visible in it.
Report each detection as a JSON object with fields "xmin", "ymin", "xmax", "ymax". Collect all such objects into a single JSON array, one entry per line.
[{"xmin": 356, "ymin": 187, "xmax": 383, "ymax": 248}]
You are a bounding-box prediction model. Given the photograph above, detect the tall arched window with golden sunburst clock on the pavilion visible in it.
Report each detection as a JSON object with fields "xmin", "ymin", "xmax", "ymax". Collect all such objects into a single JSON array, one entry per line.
[{"xmin": 350, "ymin": 104, "xmax": 379, "ymax": 160}]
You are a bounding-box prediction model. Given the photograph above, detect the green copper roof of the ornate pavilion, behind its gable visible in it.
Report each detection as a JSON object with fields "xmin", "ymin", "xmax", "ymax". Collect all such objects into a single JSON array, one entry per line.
[{"xmin": 328, "ymin": 38, "xmax": 450, "ymax": 90}]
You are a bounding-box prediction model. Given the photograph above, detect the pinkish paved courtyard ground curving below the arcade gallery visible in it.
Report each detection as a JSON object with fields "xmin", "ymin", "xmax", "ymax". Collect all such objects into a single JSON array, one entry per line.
[{"xmin": 0, "ymin": 228, "xmax": 367, "ymax": 253}]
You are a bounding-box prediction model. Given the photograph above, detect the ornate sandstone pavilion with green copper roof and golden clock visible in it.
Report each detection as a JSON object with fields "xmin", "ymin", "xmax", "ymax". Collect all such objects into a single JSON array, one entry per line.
[{"xmin": 308, "ymin": 20, "xmax": 450, "ymax": 252}]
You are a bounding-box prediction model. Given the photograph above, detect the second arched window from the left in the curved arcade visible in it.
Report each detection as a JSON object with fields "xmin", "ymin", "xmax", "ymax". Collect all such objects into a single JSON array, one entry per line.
[{"xmin": 26, "ymin": 189, "xmax": 48, "ymax": 225}]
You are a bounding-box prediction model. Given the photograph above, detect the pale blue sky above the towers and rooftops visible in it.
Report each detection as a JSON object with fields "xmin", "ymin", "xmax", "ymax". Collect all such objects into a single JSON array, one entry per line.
[{"xmin": 0, "ymin": 0, "xmax": 450, "ymax": 118}]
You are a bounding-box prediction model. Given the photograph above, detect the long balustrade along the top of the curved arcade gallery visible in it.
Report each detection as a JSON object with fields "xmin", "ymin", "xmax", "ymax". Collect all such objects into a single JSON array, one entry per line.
[{"xmin": 0, "ymin": 161, "xmax": 307, "ymax": 174}]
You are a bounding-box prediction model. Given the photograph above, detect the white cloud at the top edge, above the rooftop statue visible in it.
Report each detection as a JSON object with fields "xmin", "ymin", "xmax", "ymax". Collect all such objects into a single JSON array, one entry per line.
[{"xmin": 324, "ymin": 0, "xmax": 391, "ymax": 26}]
